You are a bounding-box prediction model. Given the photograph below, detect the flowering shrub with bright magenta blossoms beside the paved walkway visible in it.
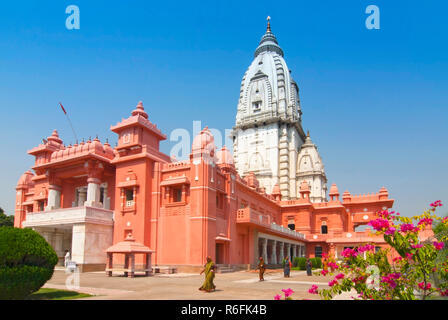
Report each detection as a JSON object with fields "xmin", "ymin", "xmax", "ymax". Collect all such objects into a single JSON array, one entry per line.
[{"xmin": 308, "ymin": 200, "xmax": 448, "ymax": 300}]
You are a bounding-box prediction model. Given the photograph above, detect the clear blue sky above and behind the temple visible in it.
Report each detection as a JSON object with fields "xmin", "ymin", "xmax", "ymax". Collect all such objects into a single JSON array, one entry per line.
[{"xmin": 0, "ymin": 0, "xmax": 448, "ymax": 219}]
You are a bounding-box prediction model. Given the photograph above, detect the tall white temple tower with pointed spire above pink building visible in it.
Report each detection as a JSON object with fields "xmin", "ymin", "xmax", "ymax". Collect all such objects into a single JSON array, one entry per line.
[{"xmin": 233, "ymin": 17, "xmax": 326, "ymax": 202}]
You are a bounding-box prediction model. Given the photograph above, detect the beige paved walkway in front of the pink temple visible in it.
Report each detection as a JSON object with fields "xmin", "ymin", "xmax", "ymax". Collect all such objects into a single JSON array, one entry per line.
[{"xmin": 45, "ymin": 270, "xmax": 336, "ymax": 300}]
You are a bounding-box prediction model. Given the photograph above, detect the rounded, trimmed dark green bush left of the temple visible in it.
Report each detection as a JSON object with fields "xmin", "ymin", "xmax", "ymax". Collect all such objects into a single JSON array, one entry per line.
[{"xmin": 0, "ymin": 227, "xmax": 58, "ymax": 300}]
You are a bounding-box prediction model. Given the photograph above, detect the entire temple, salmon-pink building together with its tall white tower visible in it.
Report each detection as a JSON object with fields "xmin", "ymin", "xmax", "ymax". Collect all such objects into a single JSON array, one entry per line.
[{"xmin": 15, "ymin": 24, "xmax": 393, "ymax": 271}]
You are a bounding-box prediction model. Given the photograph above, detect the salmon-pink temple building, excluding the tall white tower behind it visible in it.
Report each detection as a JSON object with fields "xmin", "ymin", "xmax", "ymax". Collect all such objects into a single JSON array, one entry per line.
[{"xmin": 15, "ymin": 102, "xmax": 393, "ymax": 271}]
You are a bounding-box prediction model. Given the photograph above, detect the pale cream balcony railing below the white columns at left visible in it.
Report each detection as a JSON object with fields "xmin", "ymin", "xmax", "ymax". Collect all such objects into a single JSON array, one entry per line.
[{"xmin": 23, "ymin": 206, "xmax": 114, "ymax": 227}]
